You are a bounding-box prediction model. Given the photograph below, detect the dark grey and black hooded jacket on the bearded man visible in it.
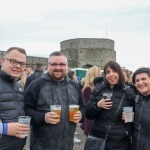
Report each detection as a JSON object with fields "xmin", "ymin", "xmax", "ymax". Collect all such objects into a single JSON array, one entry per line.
[{"xmin": 25, "ymin": 73, "xmax": 84, "ymax": 150}]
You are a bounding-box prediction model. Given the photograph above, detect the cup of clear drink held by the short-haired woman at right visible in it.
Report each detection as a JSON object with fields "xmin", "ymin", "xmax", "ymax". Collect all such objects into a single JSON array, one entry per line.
[{"xmin": 123, "ymin": 106, "xmax": 133, "ymax": 122}]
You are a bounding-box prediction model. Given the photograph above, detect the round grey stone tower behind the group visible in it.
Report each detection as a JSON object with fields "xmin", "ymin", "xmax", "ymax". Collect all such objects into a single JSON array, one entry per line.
[{"xmin": 60, "ymin": 38, "xmax": 116, "ymax": 68}]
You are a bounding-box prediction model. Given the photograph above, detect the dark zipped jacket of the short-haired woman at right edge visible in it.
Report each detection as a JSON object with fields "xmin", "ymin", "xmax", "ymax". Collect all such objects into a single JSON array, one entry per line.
[{"xmin": 133, "ymin": 94, "xmax": 150, "ymax": 150}]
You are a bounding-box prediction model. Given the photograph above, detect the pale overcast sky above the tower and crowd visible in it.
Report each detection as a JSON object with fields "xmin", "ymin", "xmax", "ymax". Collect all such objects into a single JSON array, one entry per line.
[{"xmin": 0, "ymin": 0, "xmax": 150, "ymax": 71}]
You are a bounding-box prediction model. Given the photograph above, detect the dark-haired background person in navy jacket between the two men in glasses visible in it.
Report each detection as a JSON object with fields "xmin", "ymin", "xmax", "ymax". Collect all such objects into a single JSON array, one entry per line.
[{"xmin": 24, "ymin": 62, "xmax": 43, "ymax": 90}]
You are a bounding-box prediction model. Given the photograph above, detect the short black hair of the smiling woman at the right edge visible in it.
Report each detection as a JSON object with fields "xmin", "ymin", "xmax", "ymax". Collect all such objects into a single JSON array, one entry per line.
[{"xmin": 132, "ymin": 67, "xmax": 150, "ymax": 84}]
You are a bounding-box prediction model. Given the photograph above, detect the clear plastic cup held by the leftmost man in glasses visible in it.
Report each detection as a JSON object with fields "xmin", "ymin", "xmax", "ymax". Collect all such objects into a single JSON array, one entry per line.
[{"xmin": 18, "ymin": 116, "xmax": 31, "ymax": 137}]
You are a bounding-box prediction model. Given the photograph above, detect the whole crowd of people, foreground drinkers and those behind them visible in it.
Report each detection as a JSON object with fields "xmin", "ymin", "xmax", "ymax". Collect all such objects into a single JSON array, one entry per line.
[{"xmin": 0, "ymin": 47, "xmax": 150, "ymax": 150}]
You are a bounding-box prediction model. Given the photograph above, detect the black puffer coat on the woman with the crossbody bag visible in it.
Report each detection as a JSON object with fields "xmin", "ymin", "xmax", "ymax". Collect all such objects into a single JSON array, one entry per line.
[{"xmin": 86, "ymin": 77, "xmax": 135, "ymax": 150}]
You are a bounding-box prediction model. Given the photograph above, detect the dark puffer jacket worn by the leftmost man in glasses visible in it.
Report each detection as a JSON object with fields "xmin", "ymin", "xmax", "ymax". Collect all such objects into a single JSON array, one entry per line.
[{"xmin": 0, "ymin": 70, "xmax": 26, "ymax": 150}]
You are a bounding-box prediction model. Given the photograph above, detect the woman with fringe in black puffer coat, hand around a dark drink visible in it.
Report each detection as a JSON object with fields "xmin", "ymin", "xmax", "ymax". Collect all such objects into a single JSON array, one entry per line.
[{"xmin": 86, "ymin": 61, "xmax": 135, "ymax": 150}]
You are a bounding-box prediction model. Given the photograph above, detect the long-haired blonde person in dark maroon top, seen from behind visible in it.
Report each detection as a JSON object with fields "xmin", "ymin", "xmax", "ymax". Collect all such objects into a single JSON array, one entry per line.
[{"xmin": 80, "ymin": 66, "xmax": 101, "ymax": 136}]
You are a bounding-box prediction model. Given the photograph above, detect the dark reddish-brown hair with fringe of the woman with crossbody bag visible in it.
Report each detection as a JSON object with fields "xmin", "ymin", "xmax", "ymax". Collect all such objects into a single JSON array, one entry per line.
[{"xmin": 104, "ymin": 60, "xmax": 125, "ymax": 86}]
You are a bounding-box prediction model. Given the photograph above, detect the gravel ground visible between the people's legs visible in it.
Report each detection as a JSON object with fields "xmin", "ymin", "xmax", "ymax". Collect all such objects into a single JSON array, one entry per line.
[{"xmin": 24, "ymin": 124, "xmax": 86, "ymax": 150}]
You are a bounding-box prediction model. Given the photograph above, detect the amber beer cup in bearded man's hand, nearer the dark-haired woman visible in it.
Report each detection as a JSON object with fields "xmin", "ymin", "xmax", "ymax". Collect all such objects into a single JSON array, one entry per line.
[{"xmin": 69, "ymin": 104, "xmax": 79, "ymax": 122}]
